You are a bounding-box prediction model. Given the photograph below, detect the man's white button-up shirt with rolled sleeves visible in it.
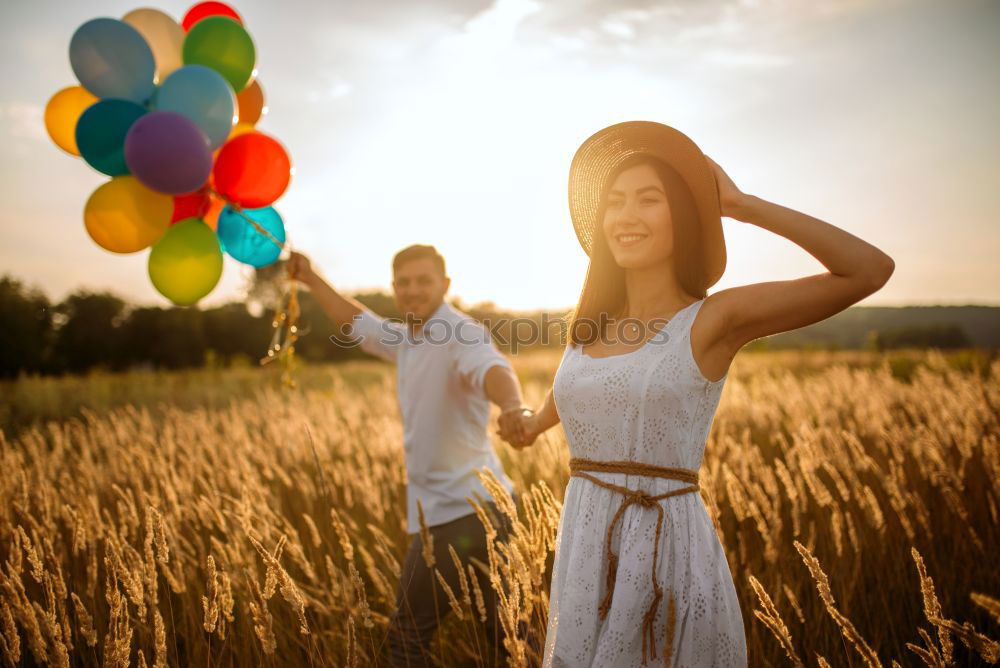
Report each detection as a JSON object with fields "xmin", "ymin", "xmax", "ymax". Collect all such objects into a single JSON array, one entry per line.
[{"xmin": 350, "ymin": 302, "xmax": 514, "ymax": 534}]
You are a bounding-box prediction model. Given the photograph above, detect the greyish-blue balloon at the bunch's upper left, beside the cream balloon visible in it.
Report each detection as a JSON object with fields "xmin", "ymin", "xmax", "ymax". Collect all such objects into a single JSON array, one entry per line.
[{"xmin": 69, "ymin": 18, "xmax": 156, "ymax": 104}]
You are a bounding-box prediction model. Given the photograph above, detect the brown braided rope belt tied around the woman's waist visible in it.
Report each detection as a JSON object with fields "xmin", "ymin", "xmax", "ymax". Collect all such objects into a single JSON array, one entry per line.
[{"xmin": 569, "ymin": 457, "xmax": 700, "ymax": 666}]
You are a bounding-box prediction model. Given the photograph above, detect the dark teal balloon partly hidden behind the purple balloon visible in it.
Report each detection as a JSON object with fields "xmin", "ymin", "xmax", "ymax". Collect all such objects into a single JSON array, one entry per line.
[{"xmin": 76, "ymin": 100, "xmax": 146, "ymax": 176}]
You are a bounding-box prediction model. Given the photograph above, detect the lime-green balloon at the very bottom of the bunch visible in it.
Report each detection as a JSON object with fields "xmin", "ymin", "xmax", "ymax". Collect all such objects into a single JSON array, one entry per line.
[{"xmin": 149, "ymin": 218, "xmax": 222, "ymax": 306}]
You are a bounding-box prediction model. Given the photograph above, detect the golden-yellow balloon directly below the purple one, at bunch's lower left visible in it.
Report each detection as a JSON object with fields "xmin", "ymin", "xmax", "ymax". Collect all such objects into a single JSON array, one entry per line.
[{"xmin": 83, "ymin": 174, "xmax": 174, "ymax": 253}]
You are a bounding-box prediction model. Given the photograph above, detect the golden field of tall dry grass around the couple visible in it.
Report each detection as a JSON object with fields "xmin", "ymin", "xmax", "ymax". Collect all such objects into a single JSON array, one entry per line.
[{"xmin": 0, "ymin": 351, "xmax": 1000, "ymax": 667}]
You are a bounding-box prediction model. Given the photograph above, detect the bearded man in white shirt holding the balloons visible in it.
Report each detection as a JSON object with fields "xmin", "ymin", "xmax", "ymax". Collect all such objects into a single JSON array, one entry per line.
[{"xmin": 289, "ymin": 245, "xmax": 523, "ymax": 666}]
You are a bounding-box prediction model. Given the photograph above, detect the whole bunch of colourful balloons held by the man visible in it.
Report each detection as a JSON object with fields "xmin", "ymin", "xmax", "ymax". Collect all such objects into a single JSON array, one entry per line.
[{"xmin": 45, "ymin": 2, "xmax": 291, "ymax": 305}]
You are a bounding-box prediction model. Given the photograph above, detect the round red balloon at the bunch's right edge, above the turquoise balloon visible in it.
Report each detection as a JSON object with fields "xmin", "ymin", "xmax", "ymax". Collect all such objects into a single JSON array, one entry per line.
[{"xmin": 212, "ymin": 132, "xmax": 292, "ymax": 209}]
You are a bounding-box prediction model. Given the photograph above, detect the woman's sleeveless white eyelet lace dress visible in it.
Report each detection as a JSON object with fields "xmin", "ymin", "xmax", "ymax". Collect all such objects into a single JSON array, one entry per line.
[{"xmin": 543, "ymin": 299, "xmax": 747, "ymax": 668}]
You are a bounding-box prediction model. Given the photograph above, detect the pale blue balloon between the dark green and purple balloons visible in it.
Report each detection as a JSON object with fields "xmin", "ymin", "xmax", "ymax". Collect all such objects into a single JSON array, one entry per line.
[{"xmin": 152, "ymin": 65, "xmax": 236, "ymax": 150}]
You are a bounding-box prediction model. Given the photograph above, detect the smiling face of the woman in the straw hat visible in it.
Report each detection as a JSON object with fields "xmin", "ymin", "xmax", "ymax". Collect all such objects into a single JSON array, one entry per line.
[{"xmin": 602, "ymin": 165, "xmax": 674, "ymax": 269}]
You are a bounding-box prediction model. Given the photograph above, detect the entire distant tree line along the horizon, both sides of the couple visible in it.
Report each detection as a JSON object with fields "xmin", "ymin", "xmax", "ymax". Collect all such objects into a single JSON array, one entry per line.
[{"xmin": 0, "ymin": 276, "xmax": 995, "ymax": 378}]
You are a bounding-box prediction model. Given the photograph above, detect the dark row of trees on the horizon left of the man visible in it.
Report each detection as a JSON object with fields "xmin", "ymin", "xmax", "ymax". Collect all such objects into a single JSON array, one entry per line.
[{"xmin": 0, "ymin": 276, "xmax": 395, "ymax": 378}]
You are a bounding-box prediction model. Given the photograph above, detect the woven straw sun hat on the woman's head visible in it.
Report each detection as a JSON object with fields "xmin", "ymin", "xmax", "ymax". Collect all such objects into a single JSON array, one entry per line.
[{"xmin": 569, "ymin": 121, "xmax": 726, "ymax": 286}]
